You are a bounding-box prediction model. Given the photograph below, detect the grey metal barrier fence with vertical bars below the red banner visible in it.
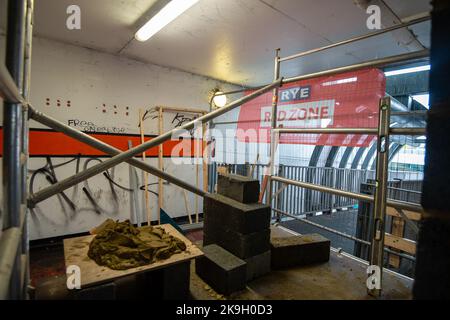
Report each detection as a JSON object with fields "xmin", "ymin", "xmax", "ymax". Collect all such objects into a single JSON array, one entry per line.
[{"xmin": 208, "ymin": 163, "xmax": 421, "ymax": 215}]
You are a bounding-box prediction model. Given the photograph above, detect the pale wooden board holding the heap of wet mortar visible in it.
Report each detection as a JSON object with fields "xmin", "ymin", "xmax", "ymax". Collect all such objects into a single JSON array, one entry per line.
[{"xmin": 64, "ymin": 224, "xmax": 203, "ymax": 288}]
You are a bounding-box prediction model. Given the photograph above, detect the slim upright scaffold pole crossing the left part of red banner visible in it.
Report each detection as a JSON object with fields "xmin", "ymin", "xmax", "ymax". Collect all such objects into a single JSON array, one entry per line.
[{"xmin": 267, "ymin": 49, "xmax": 281, "ymax": 222}]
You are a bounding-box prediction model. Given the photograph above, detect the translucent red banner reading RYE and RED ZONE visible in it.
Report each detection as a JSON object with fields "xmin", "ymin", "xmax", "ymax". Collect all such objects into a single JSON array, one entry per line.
[{"xmin": 237, "ymin": 69, "xmax": 386, "ymax": 147}]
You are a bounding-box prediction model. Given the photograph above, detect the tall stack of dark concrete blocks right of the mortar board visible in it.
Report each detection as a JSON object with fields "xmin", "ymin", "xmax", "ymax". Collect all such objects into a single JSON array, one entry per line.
[{"xmin": 196, "ymin": 175, "xmax": 271, "ymax": 294}]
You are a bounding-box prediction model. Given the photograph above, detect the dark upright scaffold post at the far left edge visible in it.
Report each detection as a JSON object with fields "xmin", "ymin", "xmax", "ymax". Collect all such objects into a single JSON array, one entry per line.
[{"xmin": 2, "ymin": 0, "xmax": 27, "ymax": 299}]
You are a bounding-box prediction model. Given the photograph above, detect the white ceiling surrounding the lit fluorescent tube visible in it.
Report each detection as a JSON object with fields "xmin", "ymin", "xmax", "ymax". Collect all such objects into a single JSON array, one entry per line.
[{"xmin": 14, "ymin": 0, "xmax": 431, "ymax": 86}]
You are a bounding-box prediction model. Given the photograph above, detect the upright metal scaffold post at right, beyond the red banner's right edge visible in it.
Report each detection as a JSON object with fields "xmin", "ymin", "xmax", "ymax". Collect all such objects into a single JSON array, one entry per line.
[{"xmin": 368, "ymin": 97, "xmax": 391, "ymax": 297}]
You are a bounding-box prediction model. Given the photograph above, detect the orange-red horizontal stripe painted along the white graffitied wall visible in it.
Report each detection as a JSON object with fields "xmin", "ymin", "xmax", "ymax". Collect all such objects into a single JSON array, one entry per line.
[{"xmin": 0, "ymin": 128, "xmax": 202, "ymax": 157}]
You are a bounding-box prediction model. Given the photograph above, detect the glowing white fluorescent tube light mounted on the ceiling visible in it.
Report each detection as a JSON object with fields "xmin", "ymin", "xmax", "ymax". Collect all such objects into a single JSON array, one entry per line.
[{"xmin": 135, "ymin": 0, "xmax": 198, "ymax": 41}]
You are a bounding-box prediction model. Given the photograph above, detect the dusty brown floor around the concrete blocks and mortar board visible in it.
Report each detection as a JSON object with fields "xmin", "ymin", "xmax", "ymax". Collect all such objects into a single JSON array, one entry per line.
[{"xmin": 31, "ymin": 229, "xmax": 412, "ymax": 300}]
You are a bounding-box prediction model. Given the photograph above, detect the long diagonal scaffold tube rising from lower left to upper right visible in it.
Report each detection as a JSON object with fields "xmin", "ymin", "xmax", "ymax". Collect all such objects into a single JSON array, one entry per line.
[{"xmin": 29, "ymin": 79, "xmax": 282, "ymax": 205}]
